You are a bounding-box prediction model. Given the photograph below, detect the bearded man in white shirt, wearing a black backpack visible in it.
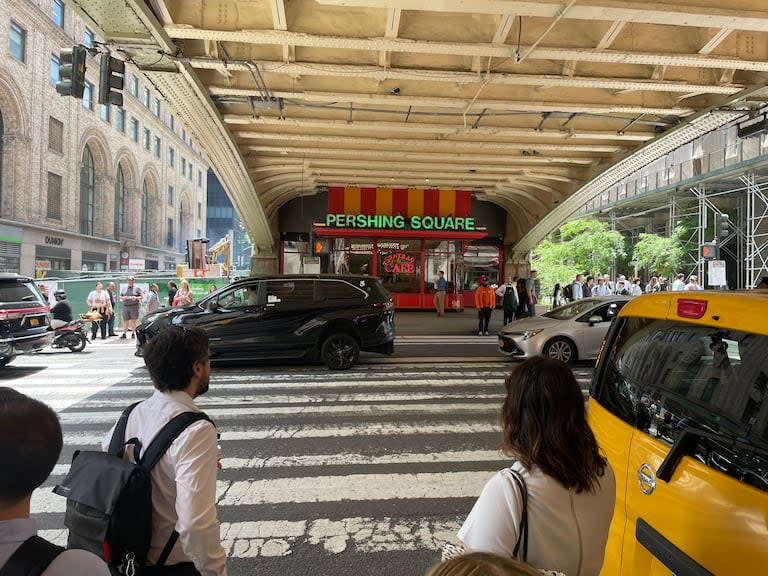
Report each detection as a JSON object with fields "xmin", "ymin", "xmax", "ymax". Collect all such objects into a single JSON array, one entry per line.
[{"xmin": 102, "ymin": 326, "xmax": 227, "ymax": 576}]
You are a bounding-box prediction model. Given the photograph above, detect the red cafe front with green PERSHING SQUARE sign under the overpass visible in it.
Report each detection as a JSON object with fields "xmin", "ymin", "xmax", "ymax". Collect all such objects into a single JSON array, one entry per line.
[{"xmin": 278, "ymin": 187, "xmax": 506, "ymax": 309}]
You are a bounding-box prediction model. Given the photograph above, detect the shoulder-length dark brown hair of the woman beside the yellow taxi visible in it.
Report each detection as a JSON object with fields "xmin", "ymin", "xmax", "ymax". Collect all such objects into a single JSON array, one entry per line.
[{"xmin": 501, "ymin": 356, "xmax": 606, "ymax": 493}]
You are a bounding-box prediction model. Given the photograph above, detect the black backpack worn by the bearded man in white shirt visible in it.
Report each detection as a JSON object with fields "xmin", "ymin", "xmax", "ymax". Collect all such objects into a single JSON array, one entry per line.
[{"xmin": 53, "ymin": 402, "xmax": 213, "ymax": 575}]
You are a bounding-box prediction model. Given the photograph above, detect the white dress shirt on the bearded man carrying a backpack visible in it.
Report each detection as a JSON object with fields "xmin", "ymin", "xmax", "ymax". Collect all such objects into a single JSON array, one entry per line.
[{"xmin": 102, "ymin": 390, "xmax": 227, "ymax": 576}]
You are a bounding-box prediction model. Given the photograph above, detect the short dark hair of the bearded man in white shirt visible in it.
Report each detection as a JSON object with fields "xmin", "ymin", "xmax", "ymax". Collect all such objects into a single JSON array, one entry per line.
[{"xmin": 144, "ymin": 326, "xmax": 209, "ymax": 392}]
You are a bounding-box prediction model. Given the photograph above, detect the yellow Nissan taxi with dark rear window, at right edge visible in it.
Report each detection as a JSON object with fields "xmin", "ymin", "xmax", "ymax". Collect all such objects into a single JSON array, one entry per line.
[{"xmin": 588, "ymin": 290, "xmax": 768, "ymax": 576}]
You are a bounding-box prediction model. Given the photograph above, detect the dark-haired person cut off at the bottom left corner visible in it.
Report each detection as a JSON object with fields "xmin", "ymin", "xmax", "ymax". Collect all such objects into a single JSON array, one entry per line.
[{"xmin": 0, "ymin": 388, "xmax": 110, "ymax": 576}]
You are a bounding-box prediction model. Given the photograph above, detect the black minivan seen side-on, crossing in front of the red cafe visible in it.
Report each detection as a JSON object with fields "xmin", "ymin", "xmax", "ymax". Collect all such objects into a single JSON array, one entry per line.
[{"xmin": 136, "ymin": 274, "xmax": 395, "ymax": 370}]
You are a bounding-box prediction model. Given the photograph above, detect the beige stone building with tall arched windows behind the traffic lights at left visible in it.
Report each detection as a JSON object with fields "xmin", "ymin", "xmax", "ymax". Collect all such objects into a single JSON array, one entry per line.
[{"xmin": 0, "ymin": 0, "xmax": 209, "ymax": 276}]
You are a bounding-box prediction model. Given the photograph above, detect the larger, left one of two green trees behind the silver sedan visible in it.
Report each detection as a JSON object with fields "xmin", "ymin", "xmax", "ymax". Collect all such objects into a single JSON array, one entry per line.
[{"xmin": 532, "ymin": 219, "xmax": 625, "ymax": 296}]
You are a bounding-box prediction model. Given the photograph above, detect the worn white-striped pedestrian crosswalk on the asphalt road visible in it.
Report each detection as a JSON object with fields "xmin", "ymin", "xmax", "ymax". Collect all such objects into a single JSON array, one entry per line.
[{"xmin": 27, "ymin": 359, "xmax": 591, "ymax": 576}]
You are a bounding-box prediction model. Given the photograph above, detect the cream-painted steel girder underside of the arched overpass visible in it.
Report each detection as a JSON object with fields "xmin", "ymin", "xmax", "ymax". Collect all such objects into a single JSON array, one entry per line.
[{"xmin": 68, "ymin": 0, "xmax": 768, "ymax": 247}]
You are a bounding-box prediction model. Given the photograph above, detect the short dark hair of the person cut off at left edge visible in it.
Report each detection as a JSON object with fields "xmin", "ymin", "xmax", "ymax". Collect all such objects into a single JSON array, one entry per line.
[{"xmin": 0, "ymin": 387, "xmax": 62, "ymax": 505}]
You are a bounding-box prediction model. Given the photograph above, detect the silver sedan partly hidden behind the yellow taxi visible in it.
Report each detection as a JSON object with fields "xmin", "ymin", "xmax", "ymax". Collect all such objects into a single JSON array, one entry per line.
[{"xmin": 499, "ymin": 296, "xmax": 630, "ymax": 362}]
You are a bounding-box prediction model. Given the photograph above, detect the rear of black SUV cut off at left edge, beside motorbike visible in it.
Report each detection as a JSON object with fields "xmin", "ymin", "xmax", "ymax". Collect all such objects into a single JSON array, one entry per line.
[{"xmin": 0, "ymin": 272, "xmax": 53, "ymax": 366}]
